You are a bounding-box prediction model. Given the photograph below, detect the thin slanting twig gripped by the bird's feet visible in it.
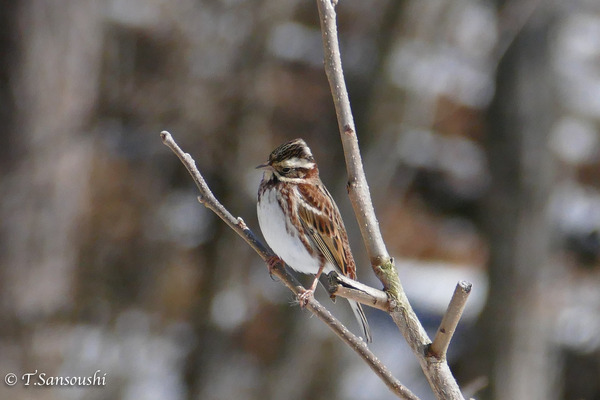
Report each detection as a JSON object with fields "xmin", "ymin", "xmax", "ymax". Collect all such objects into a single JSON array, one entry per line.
[{"xmin": 160, "ymin": 131, "xmax": 419, "ymax": 400}]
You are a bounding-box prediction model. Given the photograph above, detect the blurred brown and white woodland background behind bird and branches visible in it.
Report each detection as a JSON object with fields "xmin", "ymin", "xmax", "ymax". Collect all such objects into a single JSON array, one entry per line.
[{"xmin": 0, "ymin": 0, "xmax": 600, "ymax": 400}]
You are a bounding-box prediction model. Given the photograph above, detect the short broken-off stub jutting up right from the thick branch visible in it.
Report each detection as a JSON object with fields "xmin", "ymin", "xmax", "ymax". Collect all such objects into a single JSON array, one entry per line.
[{"xmin": 429, "ymin": 281, "xmax": 473, "ymax": 360}]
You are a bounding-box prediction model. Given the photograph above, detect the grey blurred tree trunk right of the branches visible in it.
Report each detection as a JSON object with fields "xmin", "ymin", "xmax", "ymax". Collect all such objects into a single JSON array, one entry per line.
[{"xmin": 478, "ymin": 1, "xmax": 559, "ymax": 399}]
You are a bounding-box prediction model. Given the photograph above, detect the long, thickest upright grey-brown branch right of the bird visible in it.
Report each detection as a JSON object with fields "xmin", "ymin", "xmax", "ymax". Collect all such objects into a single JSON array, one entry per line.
[{"xmin": 317, "ymin": 0, "xmax": 464, "ymax": 400}]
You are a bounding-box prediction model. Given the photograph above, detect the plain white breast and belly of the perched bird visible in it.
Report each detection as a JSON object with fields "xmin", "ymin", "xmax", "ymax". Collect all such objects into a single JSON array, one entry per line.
[{"xmin": 257, "ymin": 189, "xmax": 329, "ymax": 274}]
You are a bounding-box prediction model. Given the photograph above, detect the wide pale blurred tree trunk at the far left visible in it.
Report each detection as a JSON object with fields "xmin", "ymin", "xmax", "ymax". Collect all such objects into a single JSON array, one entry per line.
[{"xmin": 0, "ymin": 1, "xmax": 100, "ymax": 318}]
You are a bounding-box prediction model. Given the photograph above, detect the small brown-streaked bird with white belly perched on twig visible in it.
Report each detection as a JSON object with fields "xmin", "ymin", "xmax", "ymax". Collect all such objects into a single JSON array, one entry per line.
[{"xmin": 256, "ymin": 139, "xmax": 372, "ymax": 343}]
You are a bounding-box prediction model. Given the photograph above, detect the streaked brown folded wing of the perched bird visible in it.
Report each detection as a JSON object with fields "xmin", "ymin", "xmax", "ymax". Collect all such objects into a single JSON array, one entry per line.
[{"xmin": 298, "ymin": 183, "xmax": 356, "ymax": 279}]
